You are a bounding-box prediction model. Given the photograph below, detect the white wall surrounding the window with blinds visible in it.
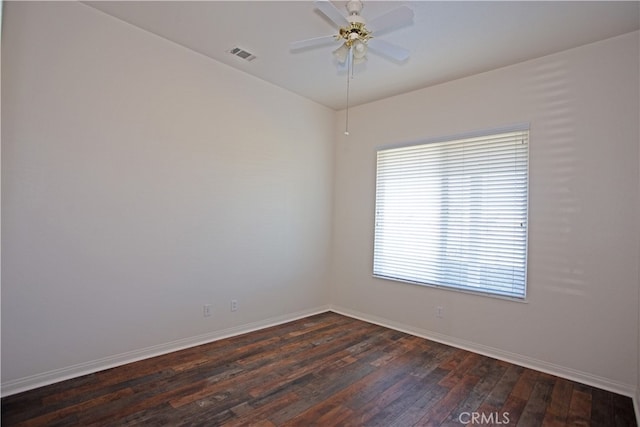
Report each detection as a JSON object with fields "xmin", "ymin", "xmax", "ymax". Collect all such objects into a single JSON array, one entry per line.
[{"xmin": 331, "ymin": 32, "xmax": 640, "ymax": 394}]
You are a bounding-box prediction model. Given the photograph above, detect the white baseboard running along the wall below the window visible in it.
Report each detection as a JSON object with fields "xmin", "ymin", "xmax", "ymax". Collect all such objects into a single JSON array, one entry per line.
[{"xmin": 331, "ymin": 305, "xmax": 640, "ymax": 398}]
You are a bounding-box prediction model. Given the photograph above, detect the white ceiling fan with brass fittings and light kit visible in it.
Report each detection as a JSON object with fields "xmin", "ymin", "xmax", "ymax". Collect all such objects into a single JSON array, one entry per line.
[{"xmin": 289, "ymin": 0, "xmax": 413, "ymax": 68}]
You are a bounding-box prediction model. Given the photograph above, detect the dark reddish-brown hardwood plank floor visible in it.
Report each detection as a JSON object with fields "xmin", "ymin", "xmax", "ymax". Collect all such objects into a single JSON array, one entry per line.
[{"xmin": 2, "ymin": 313, "xmax": 636, "ymax": 427}]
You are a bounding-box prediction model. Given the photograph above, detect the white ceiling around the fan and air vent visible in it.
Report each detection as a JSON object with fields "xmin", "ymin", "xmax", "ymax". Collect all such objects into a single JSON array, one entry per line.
[{"xmin": 85, "ymin": 0, "xmax": 640, "ymax": 110}]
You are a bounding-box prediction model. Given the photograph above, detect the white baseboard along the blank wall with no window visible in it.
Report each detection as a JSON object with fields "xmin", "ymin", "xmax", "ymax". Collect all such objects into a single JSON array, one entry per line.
[{"xmin": 1, "ymin": 305, "xmax": 329, "ymax": 397}]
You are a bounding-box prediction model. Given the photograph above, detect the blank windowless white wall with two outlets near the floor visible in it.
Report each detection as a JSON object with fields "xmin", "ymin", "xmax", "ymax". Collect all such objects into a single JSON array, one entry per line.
[{"xmin": 2, "ymin": 2, "xmax": 334, "ymax": 393}]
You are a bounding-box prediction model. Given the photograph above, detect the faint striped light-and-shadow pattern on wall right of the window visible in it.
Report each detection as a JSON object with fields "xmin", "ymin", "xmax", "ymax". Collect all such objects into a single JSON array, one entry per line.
[{"xmin": 525, "ymin": 61, "xmax": 585, "ymax": 295}]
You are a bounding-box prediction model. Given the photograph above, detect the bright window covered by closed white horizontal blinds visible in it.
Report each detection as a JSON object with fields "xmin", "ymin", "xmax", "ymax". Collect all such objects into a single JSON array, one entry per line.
[{"xmin": 373, "ymin": 127, "xmax": 529, "ymax": 299}]
